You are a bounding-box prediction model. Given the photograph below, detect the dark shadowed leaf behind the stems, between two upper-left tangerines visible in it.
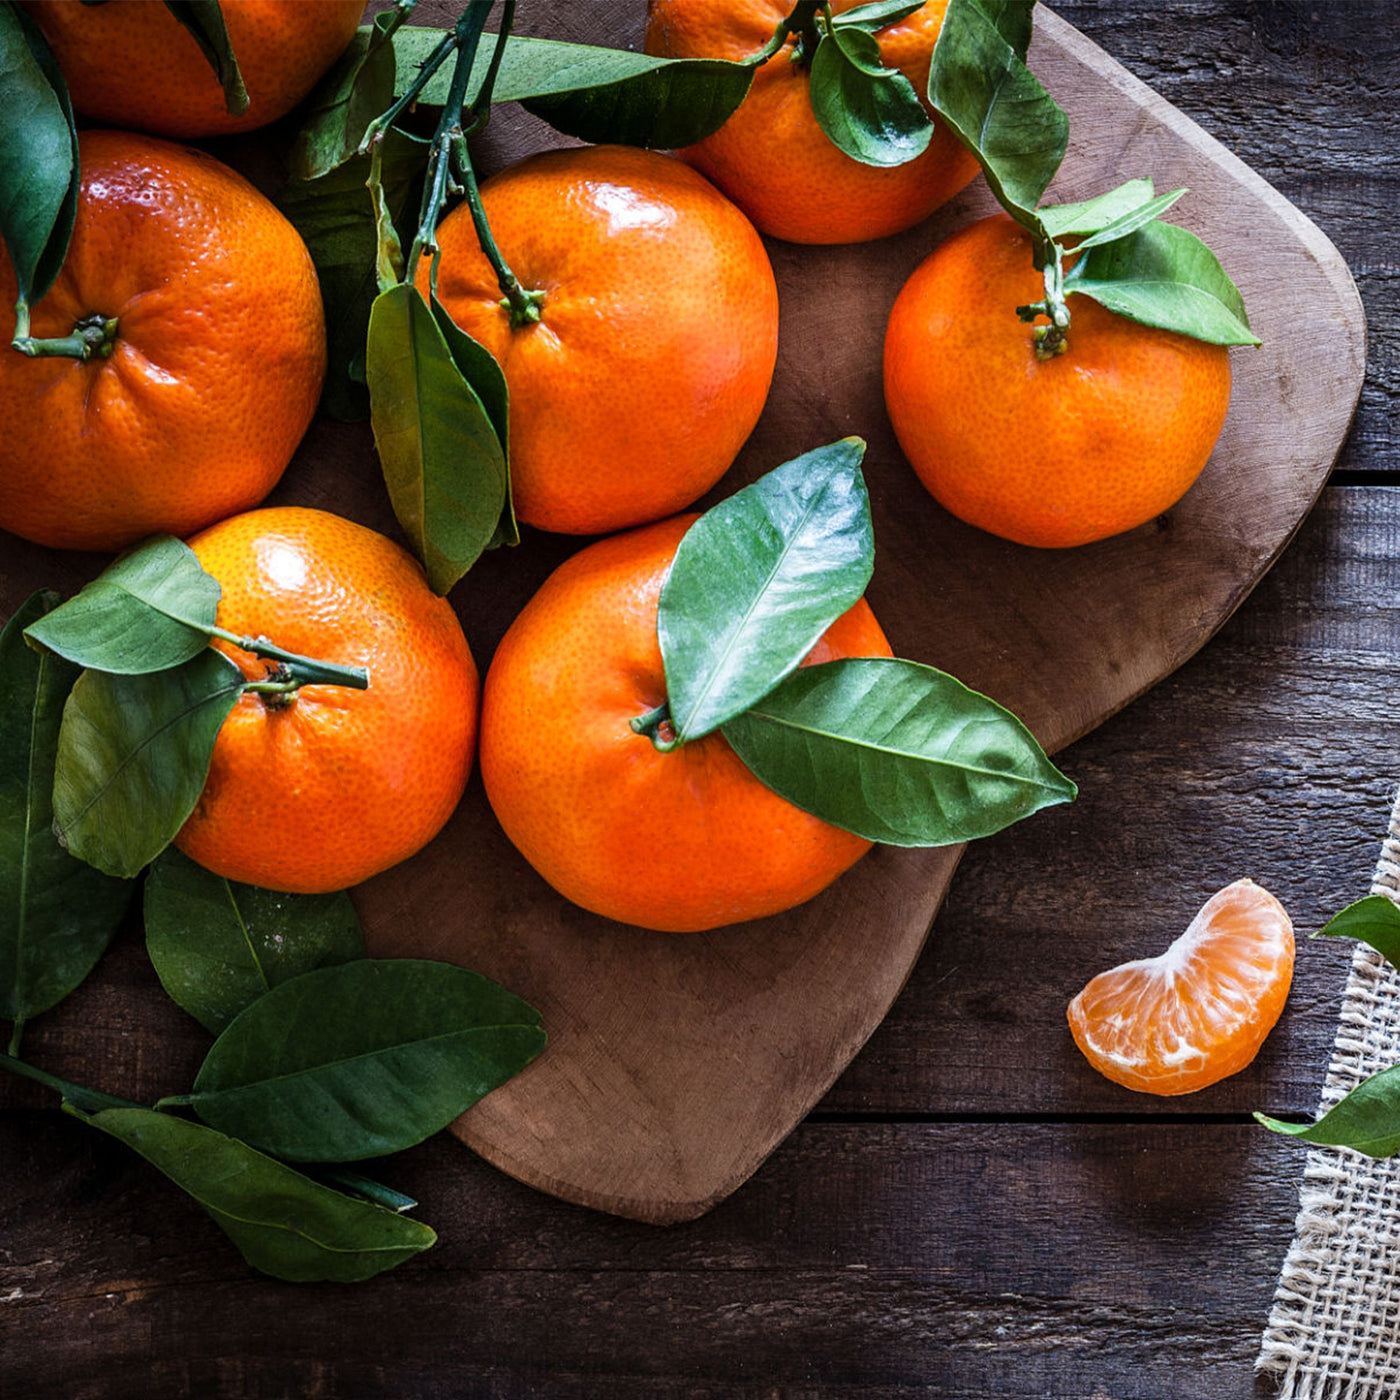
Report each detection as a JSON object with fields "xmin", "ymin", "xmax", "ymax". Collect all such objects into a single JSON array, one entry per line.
[{"xmin": 277, "ymin": 129, "xmax": 428, "ymax": 421}]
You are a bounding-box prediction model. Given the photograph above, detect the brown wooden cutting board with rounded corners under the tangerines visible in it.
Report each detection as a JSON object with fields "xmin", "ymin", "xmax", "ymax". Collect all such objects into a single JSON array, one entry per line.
[{"xmin": 0, "ymin": 0, "xmax": 1365, "ymax": 1222}]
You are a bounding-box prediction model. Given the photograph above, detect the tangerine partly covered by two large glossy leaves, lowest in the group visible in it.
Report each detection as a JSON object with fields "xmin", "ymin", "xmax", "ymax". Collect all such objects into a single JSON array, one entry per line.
[{"xmin": 482, "ymin": 517, "xmax": 890, "ymax": 932}]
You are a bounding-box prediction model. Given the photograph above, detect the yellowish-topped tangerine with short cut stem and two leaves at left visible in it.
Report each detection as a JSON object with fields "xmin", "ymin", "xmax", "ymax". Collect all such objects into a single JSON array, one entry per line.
[{"xmin": 175, "ymin": 507, "xmax": 477, "ymax": 893}]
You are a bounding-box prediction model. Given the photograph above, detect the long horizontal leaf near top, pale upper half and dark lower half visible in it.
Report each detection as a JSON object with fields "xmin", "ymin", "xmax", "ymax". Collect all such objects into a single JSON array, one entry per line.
[{"xmin": 393, "ymin": 25, "xmax": 753, "ymax": 150}]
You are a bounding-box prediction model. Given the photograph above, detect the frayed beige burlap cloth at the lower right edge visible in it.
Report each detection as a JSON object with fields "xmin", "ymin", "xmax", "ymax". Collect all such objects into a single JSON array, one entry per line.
[{"xmin": 1254, "ymin": 797, "xmax": 1400, "ymax": 1400}]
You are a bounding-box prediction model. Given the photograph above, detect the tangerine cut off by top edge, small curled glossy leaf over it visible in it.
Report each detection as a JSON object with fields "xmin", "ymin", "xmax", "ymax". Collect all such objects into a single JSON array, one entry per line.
[{"xmin": 647, "ymin": 0, "xmax": 977, "ymax": 244}]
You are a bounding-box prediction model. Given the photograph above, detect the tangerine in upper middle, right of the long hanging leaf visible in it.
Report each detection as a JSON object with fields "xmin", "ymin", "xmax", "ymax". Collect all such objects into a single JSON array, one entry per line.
[{"xmin": 417, "ymin": 146, "xmax": 778, "ymax": 535}]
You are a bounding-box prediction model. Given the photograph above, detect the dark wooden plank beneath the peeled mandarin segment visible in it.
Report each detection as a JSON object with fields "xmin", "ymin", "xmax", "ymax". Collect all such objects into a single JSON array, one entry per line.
[{"xmin": 822, "ymin": 487, "xmax": 1400, "ymax": 1116}]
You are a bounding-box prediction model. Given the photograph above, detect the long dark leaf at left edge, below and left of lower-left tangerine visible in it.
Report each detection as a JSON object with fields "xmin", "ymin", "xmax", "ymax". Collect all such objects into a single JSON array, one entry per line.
[{"xmin": 0, "ymin": 592, "xmax": 134, "ymax": 1037}]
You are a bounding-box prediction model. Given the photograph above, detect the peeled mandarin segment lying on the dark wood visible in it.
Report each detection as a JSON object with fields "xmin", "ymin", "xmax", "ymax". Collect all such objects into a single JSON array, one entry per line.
[{"xmin": 1068, "ymin": 879, "xmax": 1294, "ymax": 1095}]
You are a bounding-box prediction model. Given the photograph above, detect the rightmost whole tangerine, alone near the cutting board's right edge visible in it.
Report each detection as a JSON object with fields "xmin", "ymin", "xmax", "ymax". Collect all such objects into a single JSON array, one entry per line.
[{"xmin": 885, "ymin": 214, "xmax": 1231, "ymax": 547}]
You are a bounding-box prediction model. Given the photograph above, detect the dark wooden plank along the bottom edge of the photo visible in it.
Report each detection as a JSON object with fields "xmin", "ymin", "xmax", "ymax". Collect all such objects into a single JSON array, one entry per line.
[{"xmin": 0, "ymin": 1112, "xmax": 1299, "ymax": 1400}]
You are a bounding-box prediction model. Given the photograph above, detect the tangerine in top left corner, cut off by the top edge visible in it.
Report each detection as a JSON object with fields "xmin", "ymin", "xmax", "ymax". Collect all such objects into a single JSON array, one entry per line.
[{"xmin": 27, "ymin": 0, "xmax": 364, "ymax": 137}]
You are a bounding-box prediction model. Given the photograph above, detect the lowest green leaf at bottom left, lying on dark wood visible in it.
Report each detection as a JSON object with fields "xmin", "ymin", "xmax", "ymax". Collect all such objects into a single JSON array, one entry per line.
[{"xmin": 67, "ymin": 1107, "xmax": 437, "ymax": 1284}]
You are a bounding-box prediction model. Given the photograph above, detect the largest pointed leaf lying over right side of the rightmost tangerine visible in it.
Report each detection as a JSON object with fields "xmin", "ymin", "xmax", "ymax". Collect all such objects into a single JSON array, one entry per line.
[{"xmin": 1064, "ymin": 223, "xmax": 1260, "ymax": 346}]
